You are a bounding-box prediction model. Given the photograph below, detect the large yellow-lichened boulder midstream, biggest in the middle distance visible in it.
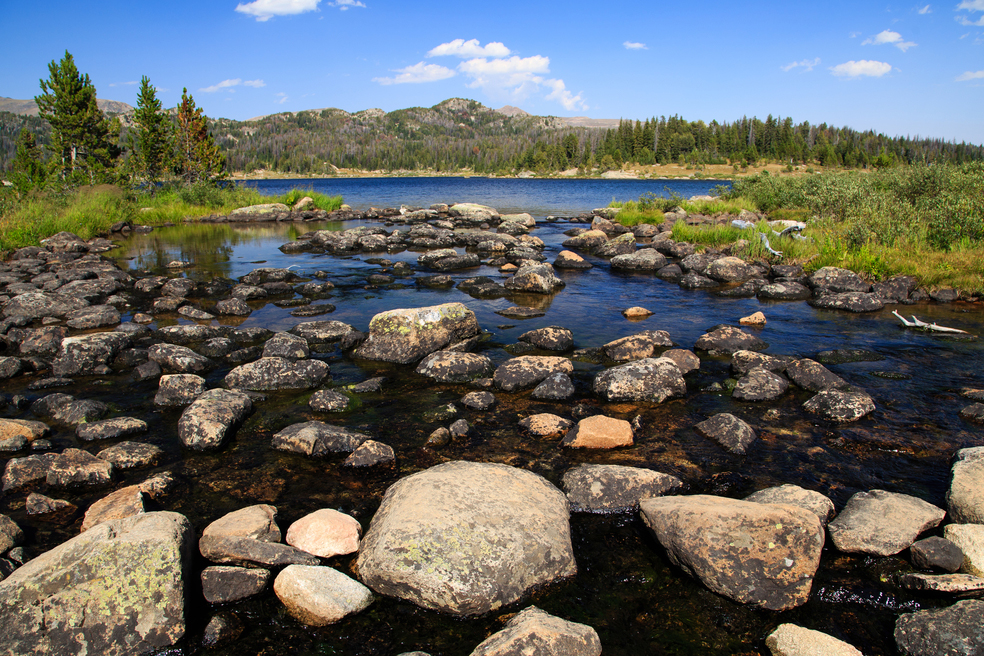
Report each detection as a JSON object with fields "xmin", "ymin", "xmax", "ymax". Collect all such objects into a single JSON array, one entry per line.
[{"xmin": 355, "ymin": 303, "xmax": 480, "ymax": 364}]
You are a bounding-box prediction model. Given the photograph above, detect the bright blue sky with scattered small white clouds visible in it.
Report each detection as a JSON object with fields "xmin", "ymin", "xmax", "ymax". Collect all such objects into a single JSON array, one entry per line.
[{"xmin": 0, "ymin": 0, "xmax": 984, "ymax": 144}]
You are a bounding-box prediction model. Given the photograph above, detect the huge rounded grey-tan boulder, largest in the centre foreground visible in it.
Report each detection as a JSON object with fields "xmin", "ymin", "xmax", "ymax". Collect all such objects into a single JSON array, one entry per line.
[{"xmin": 358, "ymin": 462, "xmax": 577, "ymax": 615}]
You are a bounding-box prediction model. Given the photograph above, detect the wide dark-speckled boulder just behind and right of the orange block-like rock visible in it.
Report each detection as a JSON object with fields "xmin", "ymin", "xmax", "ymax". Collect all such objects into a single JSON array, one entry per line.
[{"xmin": 594, "ymin": 358, "xmax": 687, "ymax": 403}]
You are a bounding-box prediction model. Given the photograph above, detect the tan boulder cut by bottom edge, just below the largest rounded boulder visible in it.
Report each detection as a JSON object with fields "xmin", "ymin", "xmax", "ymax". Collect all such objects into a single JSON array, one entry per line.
[{"xmin": 471, "ymin": 606, "xmax": 601, "ymax": 656}]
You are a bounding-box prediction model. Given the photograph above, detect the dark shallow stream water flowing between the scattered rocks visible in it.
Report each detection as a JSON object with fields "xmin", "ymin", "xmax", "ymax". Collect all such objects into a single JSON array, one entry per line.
[{"xmin": 0, "ymin": 180, "xmax": 984, "ymax": 656}]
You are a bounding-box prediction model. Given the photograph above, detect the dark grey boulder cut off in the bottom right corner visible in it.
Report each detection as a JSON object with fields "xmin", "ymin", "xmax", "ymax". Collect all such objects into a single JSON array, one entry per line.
[{"xmin": 895, "ymin": 599, "xmax": 984, "ymax": 656}]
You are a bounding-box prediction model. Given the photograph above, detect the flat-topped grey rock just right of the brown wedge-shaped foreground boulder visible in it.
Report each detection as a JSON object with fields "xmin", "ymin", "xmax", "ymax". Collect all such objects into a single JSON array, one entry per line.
[{"xmin": 827, "ymin": 490, "xmax": 946, "ymax": 556}]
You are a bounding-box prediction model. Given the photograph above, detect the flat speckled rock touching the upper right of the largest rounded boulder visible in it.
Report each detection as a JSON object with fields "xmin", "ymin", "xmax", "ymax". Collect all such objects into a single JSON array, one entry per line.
[{"xmin": 562, "ymin": 465, "xmax": 683, "ymax": 513}]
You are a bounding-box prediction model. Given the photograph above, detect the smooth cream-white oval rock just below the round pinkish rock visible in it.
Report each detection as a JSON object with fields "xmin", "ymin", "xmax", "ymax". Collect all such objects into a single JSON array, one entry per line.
[{"xmin": 273, "ymin": 565, "xmax": 373, "ymax": 626}]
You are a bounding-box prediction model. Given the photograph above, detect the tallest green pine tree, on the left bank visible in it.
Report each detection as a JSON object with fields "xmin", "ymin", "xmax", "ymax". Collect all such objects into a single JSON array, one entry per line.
[{"xmin": 34, "ymin": 50, "xmax": 120, "ymax": 181}]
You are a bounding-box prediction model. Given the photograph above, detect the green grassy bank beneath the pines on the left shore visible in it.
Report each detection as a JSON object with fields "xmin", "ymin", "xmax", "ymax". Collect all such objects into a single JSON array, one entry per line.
[{"xmin": 0, "ymin": 185, "xmax": 342, "ymax": 251}]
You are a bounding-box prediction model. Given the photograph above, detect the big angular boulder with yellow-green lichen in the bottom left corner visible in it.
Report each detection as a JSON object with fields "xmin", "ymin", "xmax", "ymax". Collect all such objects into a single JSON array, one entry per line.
[{"xmin": 0, "ymin": 512, "xmax": 193, "ymax": 656}]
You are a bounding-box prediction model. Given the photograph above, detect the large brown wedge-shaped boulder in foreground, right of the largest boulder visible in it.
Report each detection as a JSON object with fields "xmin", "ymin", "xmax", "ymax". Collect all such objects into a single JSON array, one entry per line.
[{"xmin": 639, "ymin": 495, "xmax": 824, "ymax": 610}]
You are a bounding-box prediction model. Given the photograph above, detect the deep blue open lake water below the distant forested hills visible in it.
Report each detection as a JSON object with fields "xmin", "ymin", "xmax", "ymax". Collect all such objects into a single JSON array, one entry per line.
[{"xmin": 238, "ymin": 177, "xmax": 729, "ymax": 216}]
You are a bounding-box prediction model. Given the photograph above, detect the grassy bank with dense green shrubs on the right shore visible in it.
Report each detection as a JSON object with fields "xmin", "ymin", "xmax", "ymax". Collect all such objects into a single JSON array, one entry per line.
[{"xmin": 613, "ymin": 163, "xmax": 984, "ymax": 294}]
